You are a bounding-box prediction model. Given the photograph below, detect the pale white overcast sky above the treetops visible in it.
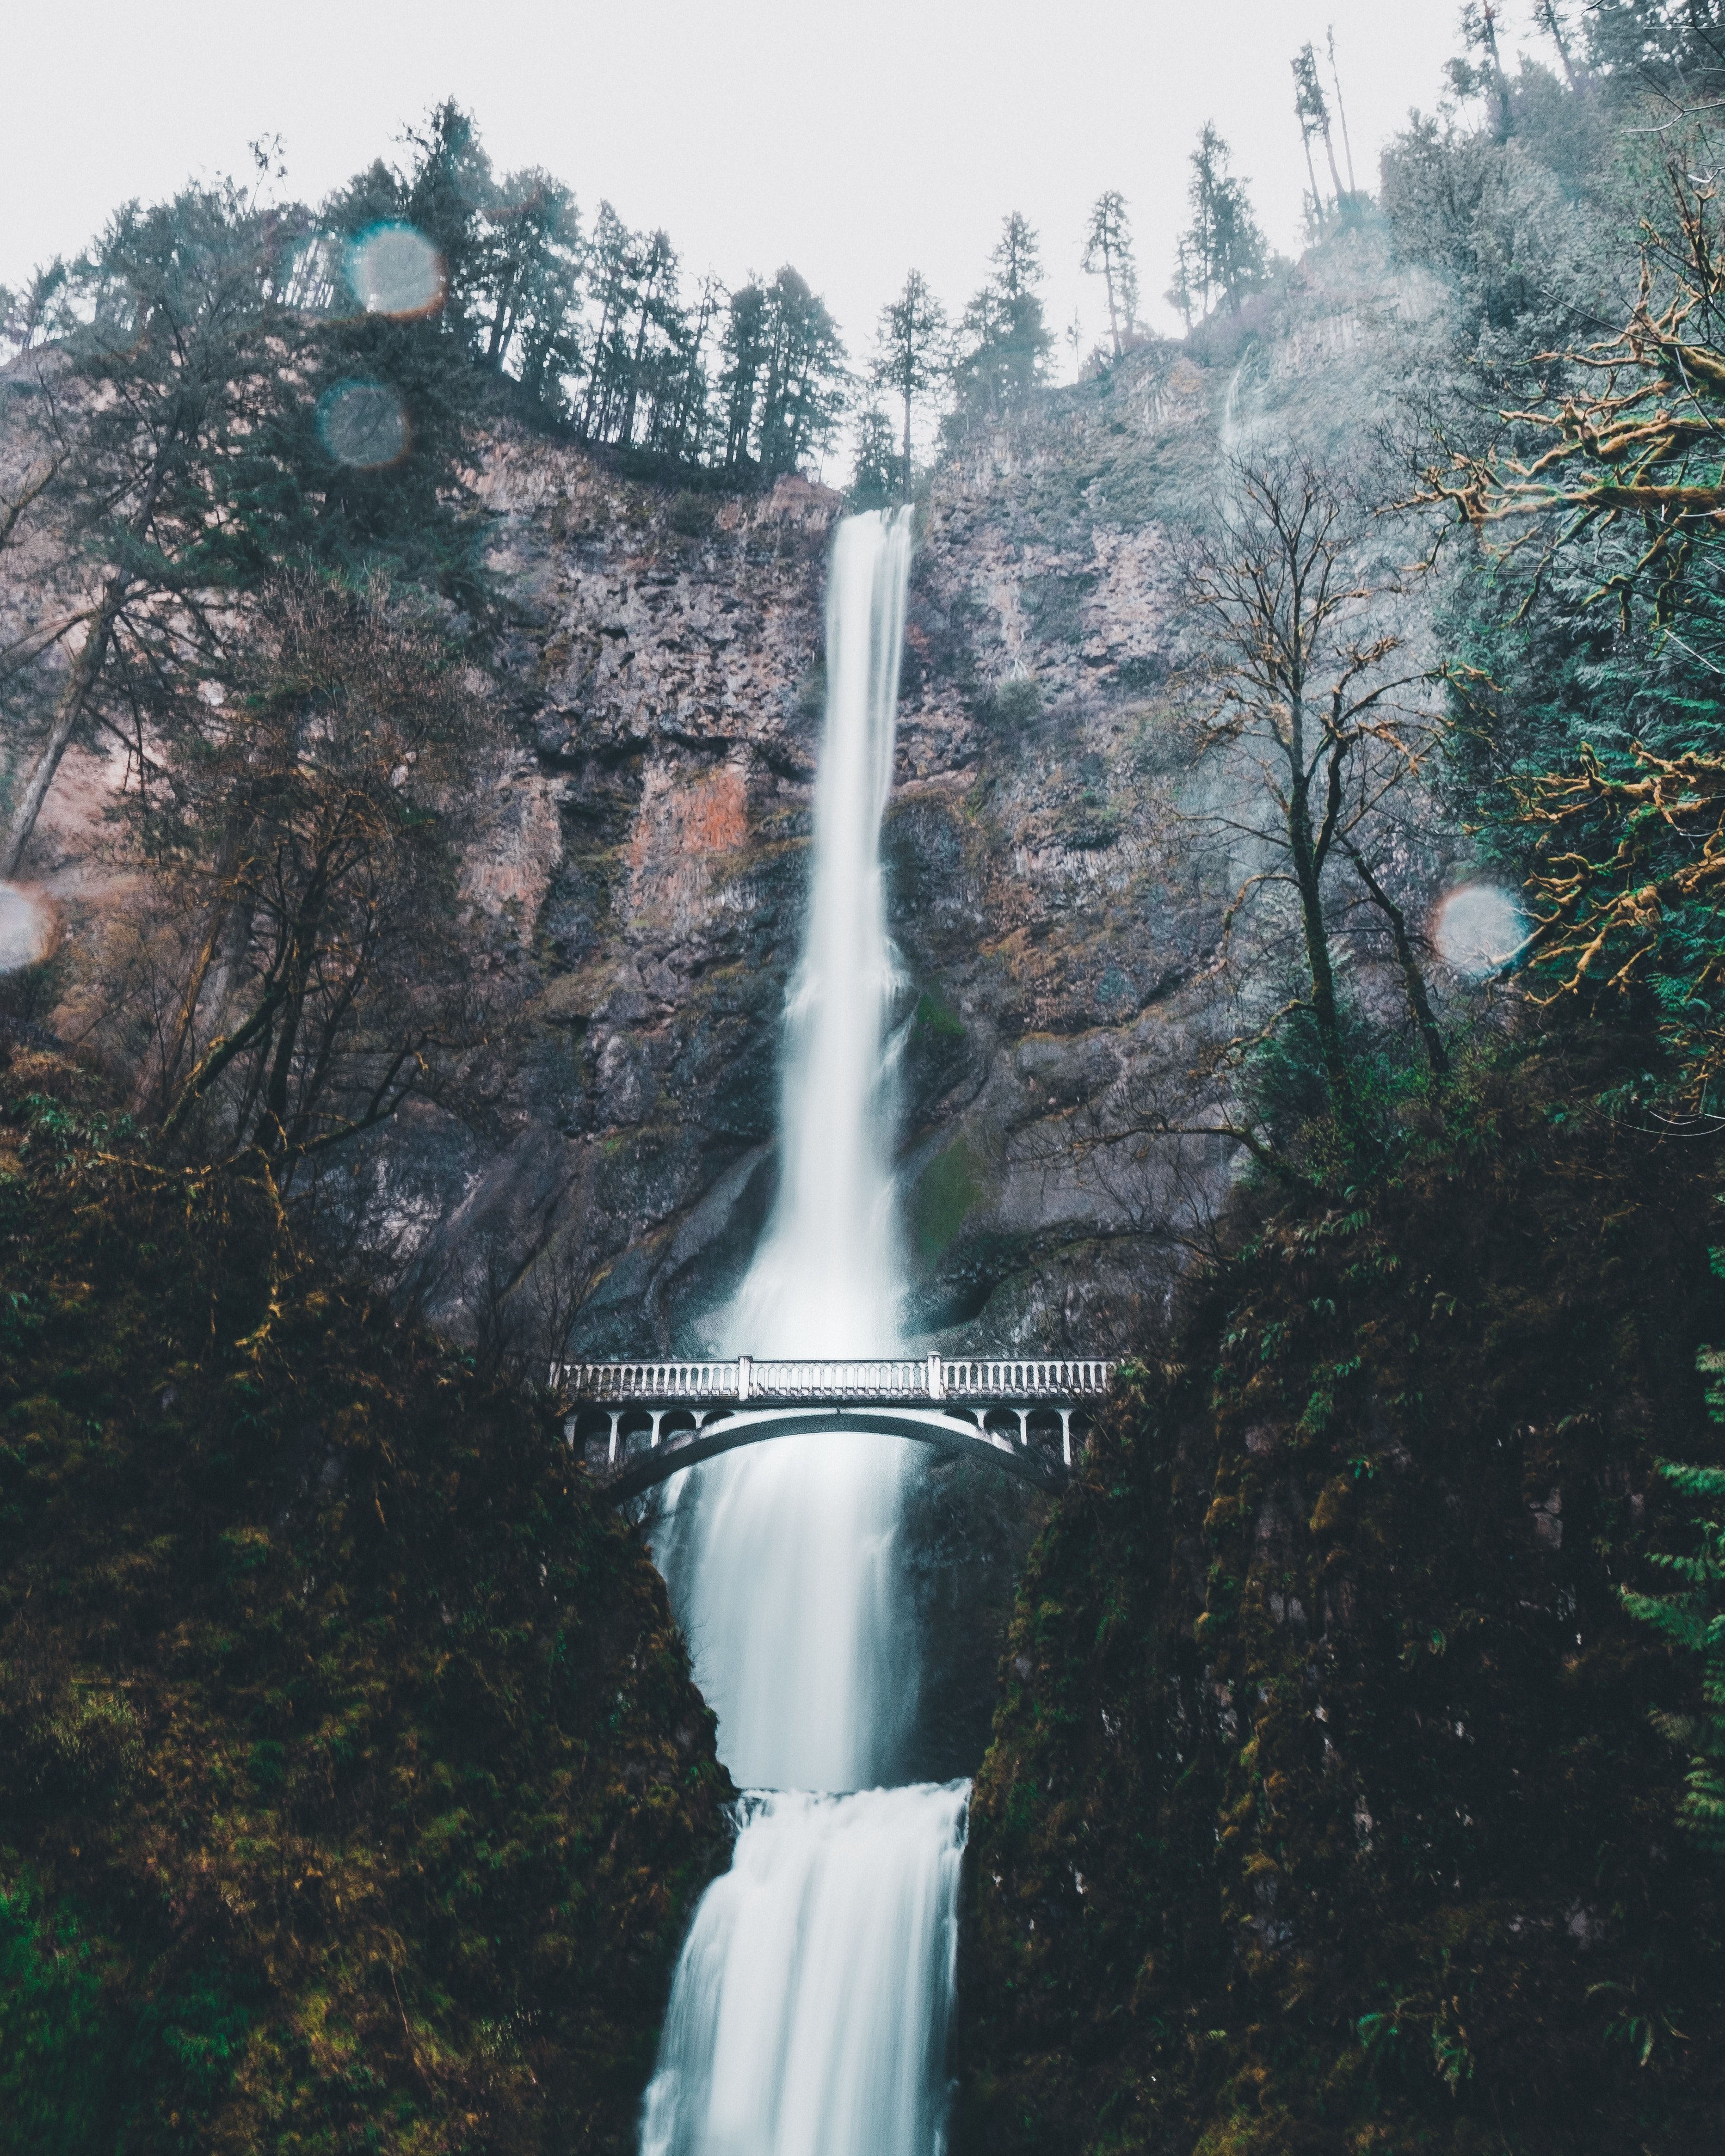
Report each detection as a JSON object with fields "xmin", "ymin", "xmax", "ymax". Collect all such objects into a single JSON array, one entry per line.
[{"xmin": 0, "ymin": 0, "xmax": 1533, "ymax": 379}]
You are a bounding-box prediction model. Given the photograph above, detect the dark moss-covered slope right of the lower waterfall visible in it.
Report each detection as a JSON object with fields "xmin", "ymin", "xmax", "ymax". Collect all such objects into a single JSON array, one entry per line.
[{"xmin": 961, "ymin": 1080, "xmax": 1725, "ymax": 2156}]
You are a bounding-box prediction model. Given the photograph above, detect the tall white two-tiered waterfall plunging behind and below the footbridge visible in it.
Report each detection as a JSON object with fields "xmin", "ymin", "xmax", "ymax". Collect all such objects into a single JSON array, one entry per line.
[{"xmin": 641, "ymin": 511, "xmax": 968, "ymax": 2156}]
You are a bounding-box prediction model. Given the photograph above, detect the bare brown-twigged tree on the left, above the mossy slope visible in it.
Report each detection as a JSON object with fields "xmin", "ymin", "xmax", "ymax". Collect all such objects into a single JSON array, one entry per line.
[{"xmin": 144, "ymin": 578, "xmax": 509, "ymax": 1181}]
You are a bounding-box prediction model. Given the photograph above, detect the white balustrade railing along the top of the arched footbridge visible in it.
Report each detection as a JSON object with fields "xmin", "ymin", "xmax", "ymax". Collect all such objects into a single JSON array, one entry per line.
[{"xmin": 552, "ymin": 1354, "xmax": 1119, "ymax": 1408}]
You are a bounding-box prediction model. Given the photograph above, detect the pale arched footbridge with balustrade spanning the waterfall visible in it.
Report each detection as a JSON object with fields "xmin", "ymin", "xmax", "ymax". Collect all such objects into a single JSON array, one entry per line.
[{"xmin": 552, "ymin": 1354, "xmax": 1119, "ymax": 1503}]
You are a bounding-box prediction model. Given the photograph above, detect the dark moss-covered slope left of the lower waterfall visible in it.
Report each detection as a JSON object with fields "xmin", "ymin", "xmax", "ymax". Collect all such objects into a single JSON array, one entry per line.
[{"xmin": 0, "ymin": 1065, "xmax": 729, "ymax": 2156}]
